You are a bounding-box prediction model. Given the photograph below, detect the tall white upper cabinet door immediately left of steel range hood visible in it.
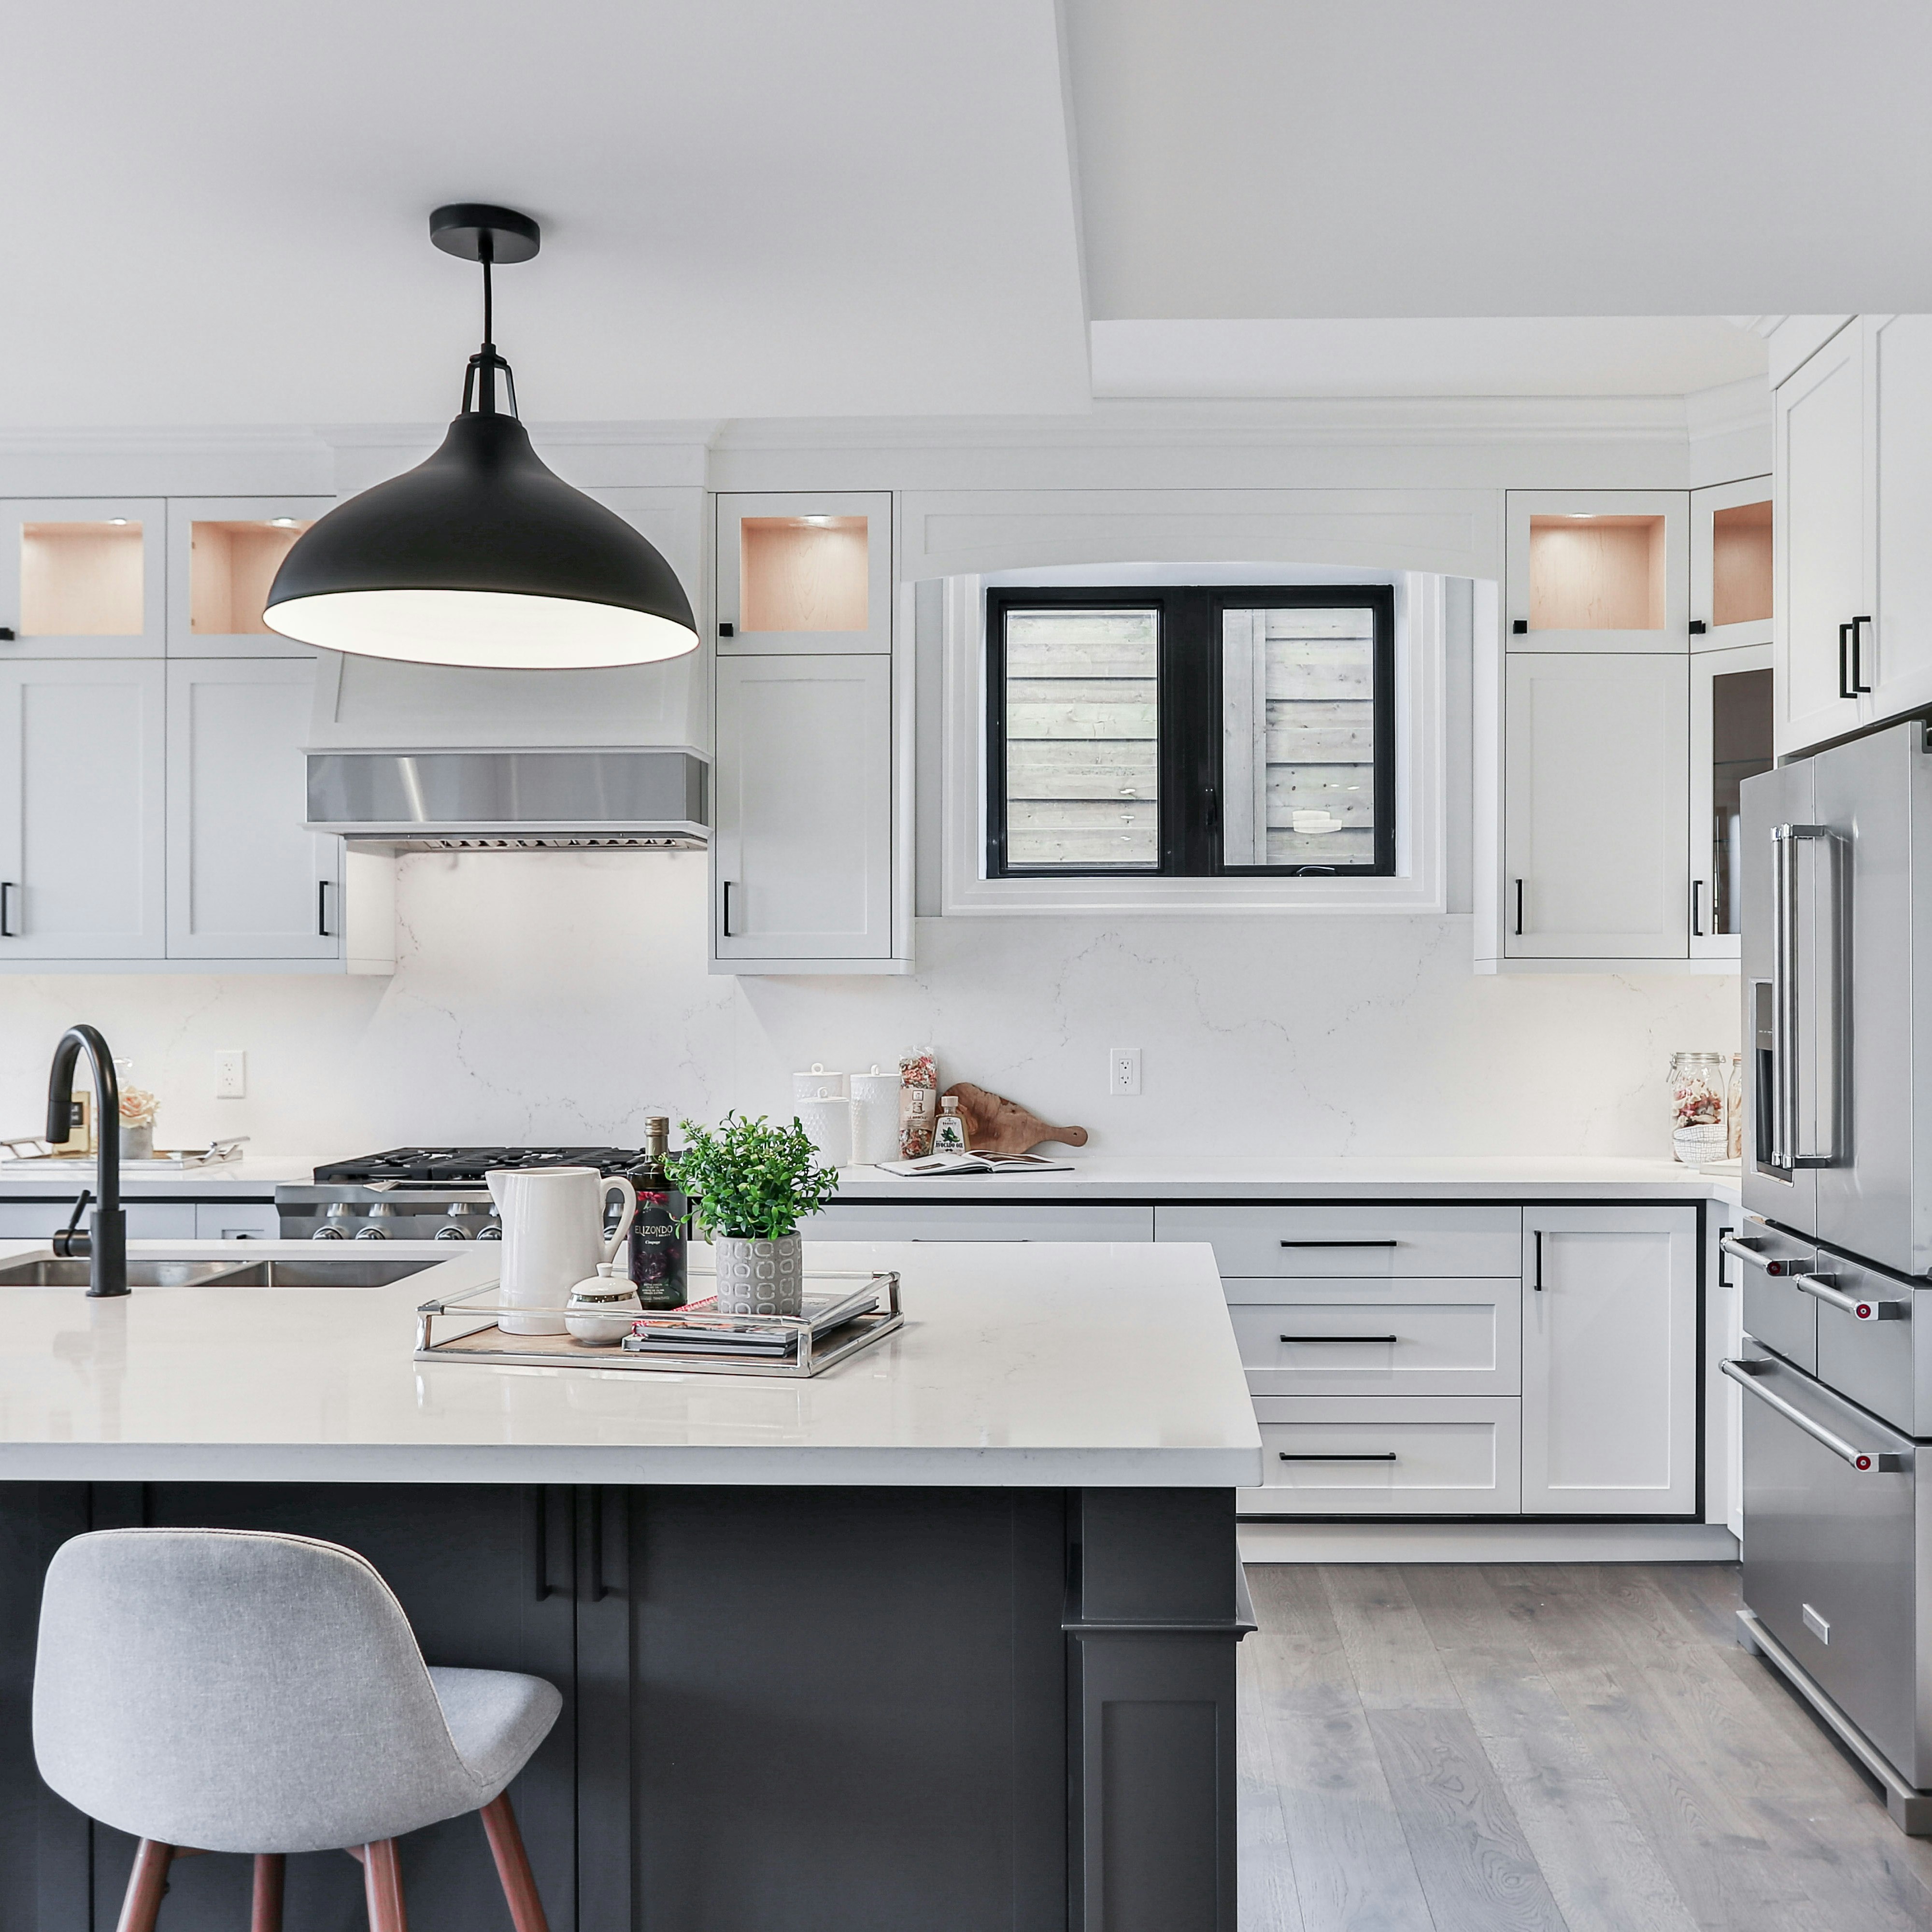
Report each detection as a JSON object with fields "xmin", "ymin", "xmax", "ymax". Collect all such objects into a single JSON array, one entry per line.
[{"xmin": 168, "ymin": 657, "xmax": 344, "ymax": 960}]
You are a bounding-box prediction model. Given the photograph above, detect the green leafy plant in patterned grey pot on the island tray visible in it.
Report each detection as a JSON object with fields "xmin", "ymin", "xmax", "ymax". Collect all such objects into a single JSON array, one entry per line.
[{"xmin": 665, "ymin": 1113, "xmax": 838, "ymax": 1316}]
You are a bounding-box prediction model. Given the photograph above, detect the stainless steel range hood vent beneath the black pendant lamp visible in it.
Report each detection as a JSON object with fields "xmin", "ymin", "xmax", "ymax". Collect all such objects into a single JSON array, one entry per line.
[{"xmin": 307, "ymin": 750, "xmax": 711, "ymax": 852}]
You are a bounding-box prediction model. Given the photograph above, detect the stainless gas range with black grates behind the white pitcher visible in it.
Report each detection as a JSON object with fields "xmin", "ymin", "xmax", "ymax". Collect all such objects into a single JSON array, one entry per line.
[{"xmin": 274, "ymin": 1148, "xmax": 643, "ymax": 1240}]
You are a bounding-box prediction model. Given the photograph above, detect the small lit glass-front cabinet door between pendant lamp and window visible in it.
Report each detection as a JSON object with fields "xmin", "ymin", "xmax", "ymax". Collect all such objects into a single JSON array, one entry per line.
[{"xmin": 717, "ymin": 491, "xmax": 893, "ymax": 657}]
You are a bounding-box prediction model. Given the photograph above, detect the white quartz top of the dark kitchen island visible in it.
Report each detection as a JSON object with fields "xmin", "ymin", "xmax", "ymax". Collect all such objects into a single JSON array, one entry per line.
[{"xmin": 0, "ymin": 1240, "xmax": 1262, "ymax": 1488}]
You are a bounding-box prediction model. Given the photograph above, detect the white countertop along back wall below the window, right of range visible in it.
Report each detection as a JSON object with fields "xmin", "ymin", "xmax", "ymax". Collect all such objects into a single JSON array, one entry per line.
[{"xmin": 833, "ymin": 1148, "xmax": 1737, "ymax": 1204}]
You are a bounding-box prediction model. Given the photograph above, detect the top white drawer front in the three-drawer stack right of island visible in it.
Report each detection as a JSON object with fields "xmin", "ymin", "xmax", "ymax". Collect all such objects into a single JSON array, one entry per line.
[{"xmin": 1153, "ymin": 1204, "xmax": 1522, "ymax": 1279}]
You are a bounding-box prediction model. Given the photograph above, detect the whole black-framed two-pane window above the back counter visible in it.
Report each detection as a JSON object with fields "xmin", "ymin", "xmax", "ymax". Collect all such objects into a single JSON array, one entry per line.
[{"xmin": 985, "ymin": 583, "xmax": 1395, "ymax": 879}]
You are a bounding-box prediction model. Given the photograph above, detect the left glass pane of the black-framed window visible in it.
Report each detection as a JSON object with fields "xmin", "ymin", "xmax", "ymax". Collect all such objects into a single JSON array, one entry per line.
[{"xmin": 1003, "ymin": 609, "xmax": 1161, "ymax": 871}]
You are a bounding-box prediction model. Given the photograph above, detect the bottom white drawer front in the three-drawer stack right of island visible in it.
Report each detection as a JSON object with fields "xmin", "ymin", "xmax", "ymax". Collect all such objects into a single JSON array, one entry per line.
[{"xmin": 1236, "ymin": 1395, "xmax": 1522, "ymax": 1517}]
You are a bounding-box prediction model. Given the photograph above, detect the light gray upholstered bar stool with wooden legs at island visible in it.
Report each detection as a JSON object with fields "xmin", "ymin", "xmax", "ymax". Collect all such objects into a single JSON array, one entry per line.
[{"xmin": 33, "ymin": 1530, "xmax": 562, "ymax": 1932}]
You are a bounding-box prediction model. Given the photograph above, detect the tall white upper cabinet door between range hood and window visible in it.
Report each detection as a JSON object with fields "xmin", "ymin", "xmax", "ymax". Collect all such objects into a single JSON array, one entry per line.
[{"xmin": 711, "ymin": 655, "xmax": 893, "ymax": 972}]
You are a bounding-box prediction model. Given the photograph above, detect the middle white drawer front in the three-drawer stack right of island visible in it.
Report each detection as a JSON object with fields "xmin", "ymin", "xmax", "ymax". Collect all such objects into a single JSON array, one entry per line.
[{"xmin": 1225, "ymin": 1275, "xmax": 1522, "ymax": 1395}]
